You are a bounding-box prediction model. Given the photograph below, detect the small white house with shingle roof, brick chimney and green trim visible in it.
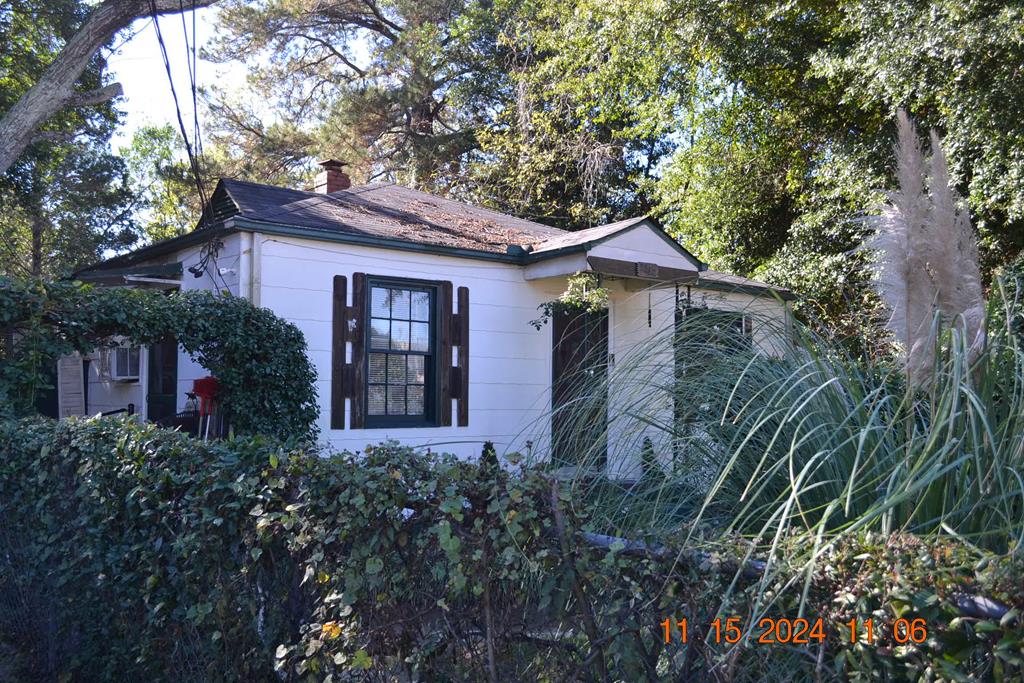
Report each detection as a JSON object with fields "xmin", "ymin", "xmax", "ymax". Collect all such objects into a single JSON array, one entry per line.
[{"xmin": 74, "ymin": 162, "xmax": 792, "ymax": 475}]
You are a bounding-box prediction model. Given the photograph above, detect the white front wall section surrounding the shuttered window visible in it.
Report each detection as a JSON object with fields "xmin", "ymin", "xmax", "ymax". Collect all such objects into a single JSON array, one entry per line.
[{"xmin": 254, "ymin": 236, "xmax": 565, "ymax": 457}]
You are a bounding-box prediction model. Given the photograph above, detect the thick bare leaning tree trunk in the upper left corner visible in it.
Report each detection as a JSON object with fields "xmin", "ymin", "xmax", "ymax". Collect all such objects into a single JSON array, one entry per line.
[{"xmin": 0, "ymin": 0, "xmax": 223, "ymax": 174}]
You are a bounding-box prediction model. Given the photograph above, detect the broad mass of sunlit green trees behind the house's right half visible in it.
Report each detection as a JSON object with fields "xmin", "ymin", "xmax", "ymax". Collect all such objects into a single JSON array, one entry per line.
[{"xmin": 489, "ymin": 0, "xmax": 1024, "ymax": 341}]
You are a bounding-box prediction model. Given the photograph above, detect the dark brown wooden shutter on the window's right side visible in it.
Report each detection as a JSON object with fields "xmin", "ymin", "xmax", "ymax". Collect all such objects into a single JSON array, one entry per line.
[{"xmin": 437, "ymin": 282, "xmax": 469, "ymax": 427}]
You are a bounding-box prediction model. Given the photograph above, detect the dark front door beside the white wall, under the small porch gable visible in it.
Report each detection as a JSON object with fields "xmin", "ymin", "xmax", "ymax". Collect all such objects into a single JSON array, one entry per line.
[{"xmin": 551, "ymin": 310, "xmax": 608, "ymax": 470}]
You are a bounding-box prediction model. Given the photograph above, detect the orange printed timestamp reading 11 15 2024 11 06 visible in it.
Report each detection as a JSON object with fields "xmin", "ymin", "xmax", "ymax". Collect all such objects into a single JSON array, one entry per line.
[{"xmin": 660, "ymin": 616, "xmax": 928, "ymax": 645}]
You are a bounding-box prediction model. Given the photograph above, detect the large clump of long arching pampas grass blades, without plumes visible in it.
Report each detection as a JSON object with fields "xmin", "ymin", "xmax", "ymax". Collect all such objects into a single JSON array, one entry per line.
[{"xmin": 556, "ymin": 288, "xmax": 1024, "ymax": 562}]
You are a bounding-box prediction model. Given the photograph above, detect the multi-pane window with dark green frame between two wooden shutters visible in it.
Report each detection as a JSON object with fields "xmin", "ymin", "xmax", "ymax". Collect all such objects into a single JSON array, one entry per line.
[{"xmin": 366, "ymin": 280, "xmax": 437, "ymax": 427}]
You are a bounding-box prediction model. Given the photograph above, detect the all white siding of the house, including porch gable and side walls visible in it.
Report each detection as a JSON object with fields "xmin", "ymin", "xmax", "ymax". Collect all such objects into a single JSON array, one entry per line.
[{"xmin": 75, "ymin": 224, "xmax": 785, "ymax": 477}]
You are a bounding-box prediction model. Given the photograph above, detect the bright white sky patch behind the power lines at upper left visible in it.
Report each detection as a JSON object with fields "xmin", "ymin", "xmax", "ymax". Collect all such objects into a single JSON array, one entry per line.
[{"xmin": 108, "ymin": 7, "xmax": 245, "ymax": 150}]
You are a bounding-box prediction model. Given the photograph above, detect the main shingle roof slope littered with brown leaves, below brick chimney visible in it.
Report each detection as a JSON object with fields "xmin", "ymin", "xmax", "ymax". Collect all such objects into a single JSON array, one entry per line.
[{"xmin": 220, "ymin": 179, "xmax": 571, "ymax": 254}]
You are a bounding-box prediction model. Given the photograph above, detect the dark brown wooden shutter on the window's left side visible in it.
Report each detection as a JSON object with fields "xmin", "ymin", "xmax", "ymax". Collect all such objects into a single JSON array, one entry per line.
[{"xmin": 331, "ymin": 272, "xmax": 367, "ymax": 429}]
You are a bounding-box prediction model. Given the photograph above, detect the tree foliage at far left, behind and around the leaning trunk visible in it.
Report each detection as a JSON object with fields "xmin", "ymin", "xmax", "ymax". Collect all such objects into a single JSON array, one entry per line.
[{"xmin": 0, "ymin": 0, "xmax": 138, "ymax": 276}]
